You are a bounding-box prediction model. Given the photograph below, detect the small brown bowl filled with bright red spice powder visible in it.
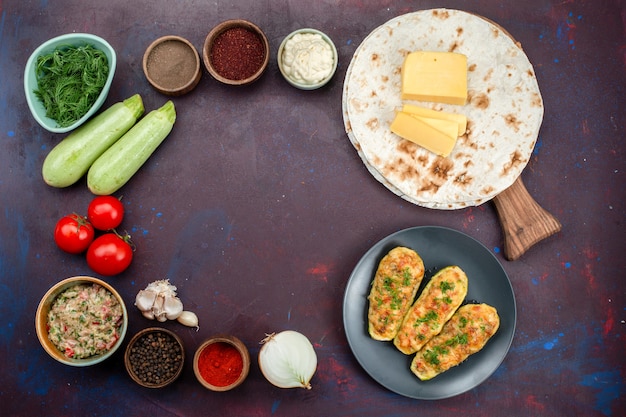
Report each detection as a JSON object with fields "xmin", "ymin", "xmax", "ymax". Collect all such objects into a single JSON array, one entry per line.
[{"xmin": 193, "ymin": 335, "xmax": 250, "ymax": 391}]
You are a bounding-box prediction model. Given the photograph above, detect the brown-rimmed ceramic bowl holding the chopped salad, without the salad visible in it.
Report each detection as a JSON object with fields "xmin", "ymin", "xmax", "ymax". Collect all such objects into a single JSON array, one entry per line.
[{"xmin": 35, "ymin": 276, "xmax": 128, "ymax": 366}]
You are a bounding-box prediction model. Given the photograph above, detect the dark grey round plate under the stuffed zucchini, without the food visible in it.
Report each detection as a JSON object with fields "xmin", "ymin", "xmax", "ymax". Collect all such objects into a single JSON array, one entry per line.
[{"xmin": 343, "ymin": 226, "xmax": 517, "ymax": 400}]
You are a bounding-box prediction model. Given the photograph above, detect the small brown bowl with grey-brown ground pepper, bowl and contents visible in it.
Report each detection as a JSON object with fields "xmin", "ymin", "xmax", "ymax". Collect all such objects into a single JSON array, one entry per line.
[{"xmin": 143, "ymin": 35, "xmax": 202, "ymax": 96}]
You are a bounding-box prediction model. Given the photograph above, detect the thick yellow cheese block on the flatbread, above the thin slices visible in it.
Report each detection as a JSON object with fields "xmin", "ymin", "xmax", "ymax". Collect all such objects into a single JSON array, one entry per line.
[{"xmin": 402, "ymin": 51, "xmax": 467, "ymax": 105}]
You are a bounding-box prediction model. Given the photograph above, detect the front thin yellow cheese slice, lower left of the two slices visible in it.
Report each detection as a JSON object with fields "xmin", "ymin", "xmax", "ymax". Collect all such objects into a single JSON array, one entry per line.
[{"xmin": 391, "ymin": 112, "xmax": 458, "ymax": 157}]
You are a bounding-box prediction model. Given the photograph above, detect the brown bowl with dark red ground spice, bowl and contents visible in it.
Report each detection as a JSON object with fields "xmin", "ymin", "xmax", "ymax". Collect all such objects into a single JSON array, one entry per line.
[{"xmin": 202, "ymin": 19, "xmax": 270, "ymax": 85}]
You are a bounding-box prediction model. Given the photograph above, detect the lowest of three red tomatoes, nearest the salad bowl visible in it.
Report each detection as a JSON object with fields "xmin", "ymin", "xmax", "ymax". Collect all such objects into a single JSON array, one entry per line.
[{"xmin": 87, "ymin": 233, "xmax": 133, "ymax": 275}]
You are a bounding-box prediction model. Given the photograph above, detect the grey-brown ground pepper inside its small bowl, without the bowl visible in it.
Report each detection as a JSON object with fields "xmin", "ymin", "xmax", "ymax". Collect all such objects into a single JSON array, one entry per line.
[{"xmin": 146, "ymin": 40, "xmax": 196, "ymax": 90}]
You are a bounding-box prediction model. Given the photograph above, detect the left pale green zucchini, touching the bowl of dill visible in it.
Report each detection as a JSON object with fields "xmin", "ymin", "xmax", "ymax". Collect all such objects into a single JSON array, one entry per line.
[{"xmin": 41, "ymin": 94, "xmax": 144, "ymax": 188}]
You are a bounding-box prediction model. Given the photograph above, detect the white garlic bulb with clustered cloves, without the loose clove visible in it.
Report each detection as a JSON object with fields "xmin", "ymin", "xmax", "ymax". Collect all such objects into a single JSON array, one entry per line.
[{"xmin": 135, "ymin": 279, "xmax": 183, "ymax": 322}]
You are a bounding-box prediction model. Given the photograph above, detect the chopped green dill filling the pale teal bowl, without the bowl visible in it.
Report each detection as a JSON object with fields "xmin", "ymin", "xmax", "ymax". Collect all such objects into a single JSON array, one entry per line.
[{"xmin": 35, "ymin": 45, "xmax": 109, "ymax": 127}]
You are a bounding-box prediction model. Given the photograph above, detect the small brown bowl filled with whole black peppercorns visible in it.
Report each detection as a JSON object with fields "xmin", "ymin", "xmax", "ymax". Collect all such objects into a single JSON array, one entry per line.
[{"xmin": 124, "ymin": 327, "xmax": 185, "ymax": 388}]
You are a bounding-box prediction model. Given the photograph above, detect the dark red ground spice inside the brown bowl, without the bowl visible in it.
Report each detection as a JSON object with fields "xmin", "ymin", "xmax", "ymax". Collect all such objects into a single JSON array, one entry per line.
[{"xmin": 210, "ymin": 28, "xmax": 265, "ymax": 80}]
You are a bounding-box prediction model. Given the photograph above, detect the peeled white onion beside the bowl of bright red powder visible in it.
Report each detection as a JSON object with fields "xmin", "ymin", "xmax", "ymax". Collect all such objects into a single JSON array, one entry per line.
[{"xmin": 259, "ymin": 330, "xmax": 317, "ymax": 389}]
